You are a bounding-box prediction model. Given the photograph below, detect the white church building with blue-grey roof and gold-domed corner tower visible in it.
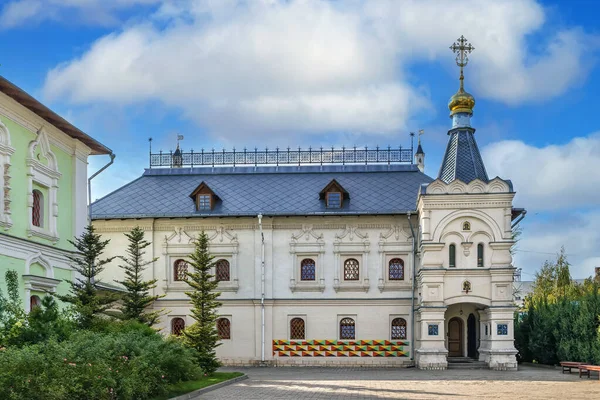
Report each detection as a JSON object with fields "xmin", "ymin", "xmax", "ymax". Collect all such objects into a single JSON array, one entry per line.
[{"xmin": 92, "ymin": 38, "xmax": 524, "ymax": 370}]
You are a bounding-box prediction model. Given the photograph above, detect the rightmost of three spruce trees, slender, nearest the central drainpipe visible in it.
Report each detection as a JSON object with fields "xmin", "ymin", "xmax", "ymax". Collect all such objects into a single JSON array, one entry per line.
[{"xmin": 183, "ymin": 232, "xmax": 221, "ymax": 374}]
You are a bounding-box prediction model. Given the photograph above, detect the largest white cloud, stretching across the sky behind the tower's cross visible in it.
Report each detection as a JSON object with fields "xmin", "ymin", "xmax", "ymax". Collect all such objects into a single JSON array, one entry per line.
[{"xmin": 44, "ymin": 0, "xmax": 588, "ymax": 139}]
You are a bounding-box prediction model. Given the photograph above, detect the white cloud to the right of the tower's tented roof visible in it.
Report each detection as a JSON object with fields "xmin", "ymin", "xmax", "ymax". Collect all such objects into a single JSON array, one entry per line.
[{"xmin": 483, "ymin": 133, "xmax": 600, "ymax": 211}]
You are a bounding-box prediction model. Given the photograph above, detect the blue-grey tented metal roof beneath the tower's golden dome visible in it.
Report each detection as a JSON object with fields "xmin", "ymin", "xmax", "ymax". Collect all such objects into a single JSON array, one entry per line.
[{"xmin": 438, "ymin": 128, "xmax": 489, "ymax": 183}]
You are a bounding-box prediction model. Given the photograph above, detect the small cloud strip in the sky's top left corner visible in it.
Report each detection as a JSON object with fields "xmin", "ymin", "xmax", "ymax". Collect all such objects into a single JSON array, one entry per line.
[{"xmin": 0, "ymin": 0, "xmax": 162, "ymax": 29}]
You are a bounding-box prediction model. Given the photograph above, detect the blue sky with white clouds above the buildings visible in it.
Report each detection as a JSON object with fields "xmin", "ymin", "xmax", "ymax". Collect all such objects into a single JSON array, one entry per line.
[{"xmin": 0, "ymin": 0, "xmax": 600, "ymax": 280}]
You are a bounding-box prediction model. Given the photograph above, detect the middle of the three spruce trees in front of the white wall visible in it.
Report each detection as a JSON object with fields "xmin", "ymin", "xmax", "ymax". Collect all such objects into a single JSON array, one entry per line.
[{"xmin": 115, "ymin": 226, "xmax": 165, "ymax": 326}]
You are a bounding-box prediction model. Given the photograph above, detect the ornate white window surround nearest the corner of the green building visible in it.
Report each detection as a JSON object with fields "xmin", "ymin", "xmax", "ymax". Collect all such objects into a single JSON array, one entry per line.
[{"xmin": 25, "ymin": 127, "xmax": 62, "ymax": 244}]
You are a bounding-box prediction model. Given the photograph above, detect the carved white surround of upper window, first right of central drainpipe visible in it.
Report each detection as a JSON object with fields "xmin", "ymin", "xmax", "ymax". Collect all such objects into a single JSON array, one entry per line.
[{"xmin": 290, "ymin": 225, "xmax": 325, "ymax": 292}]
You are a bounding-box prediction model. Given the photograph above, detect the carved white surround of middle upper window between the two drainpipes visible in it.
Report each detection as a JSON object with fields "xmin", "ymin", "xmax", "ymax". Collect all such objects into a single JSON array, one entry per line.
[{"xmin": 333, "ymin": 226, "xmax": 370, "ymax": 292}]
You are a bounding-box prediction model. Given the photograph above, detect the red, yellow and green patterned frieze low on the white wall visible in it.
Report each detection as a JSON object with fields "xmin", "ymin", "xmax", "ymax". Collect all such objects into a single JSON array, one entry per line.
[{"xmin": 273, "ymin": 339, "xmax": 409, "ymax": 357}]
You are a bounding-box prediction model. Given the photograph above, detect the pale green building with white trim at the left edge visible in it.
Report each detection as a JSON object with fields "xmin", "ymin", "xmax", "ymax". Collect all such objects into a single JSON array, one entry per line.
[{"xmin": 0, "ymin": 77, "xmax": 112, "ymax": 311}]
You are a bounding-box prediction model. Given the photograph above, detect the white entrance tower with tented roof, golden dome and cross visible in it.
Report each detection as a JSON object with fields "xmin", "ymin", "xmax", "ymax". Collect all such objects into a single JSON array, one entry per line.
[{"xmin": 415, "ymin": 36, "xmax": 517, "ymax": 369}]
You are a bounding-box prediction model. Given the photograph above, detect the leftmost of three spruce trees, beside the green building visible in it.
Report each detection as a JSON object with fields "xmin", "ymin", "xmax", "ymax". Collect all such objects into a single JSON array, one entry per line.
[{"xmin": 56, "ymin": 225, "xmax": 120, "ymax": 328}]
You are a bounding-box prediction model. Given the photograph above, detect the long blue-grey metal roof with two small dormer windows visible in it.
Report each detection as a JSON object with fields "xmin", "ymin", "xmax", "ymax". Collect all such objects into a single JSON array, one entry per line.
[{"xmin": 92, "ymin": 164, "xmax": 433, "ymax": 219}]
